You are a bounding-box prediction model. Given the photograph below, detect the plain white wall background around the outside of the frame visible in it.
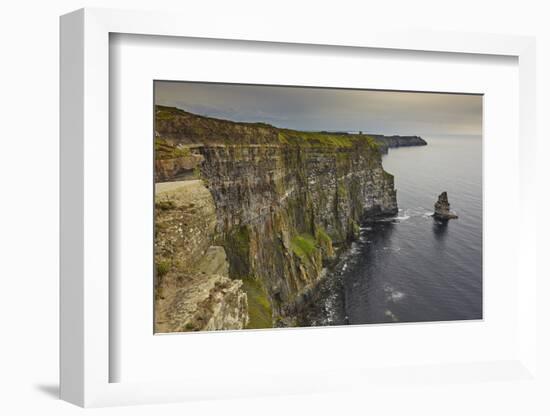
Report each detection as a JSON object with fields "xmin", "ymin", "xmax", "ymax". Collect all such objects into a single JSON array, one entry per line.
[{"xmin": 0, "ymin": 0, "xmax": 550, "ymax": 415}]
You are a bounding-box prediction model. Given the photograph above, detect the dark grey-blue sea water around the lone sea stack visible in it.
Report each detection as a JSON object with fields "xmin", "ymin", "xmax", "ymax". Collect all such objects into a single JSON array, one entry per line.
[{"xmin": 309, "ymin": 137, "xmax": 482, "ymax": 325}]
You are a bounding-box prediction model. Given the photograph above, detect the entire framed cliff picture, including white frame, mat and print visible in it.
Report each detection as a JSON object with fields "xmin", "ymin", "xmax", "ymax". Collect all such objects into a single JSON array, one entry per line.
[{"xmin": 61, "ymin": 9, "xmax": 537, "ymax": 406}]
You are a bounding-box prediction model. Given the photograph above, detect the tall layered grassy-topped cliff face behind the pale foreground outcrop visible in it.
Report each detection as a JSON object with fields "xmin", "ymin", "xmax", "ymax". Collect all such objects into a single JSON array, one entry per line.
[{"xmin": 156, "ymin": 107, "xmax": 397, "ymax": 329}]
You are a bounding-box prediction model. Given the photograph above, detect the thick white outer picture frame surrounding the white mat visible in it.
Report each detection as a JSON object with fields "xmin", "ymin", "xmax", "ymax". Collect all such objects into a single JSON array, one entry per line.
[{"xmin": 60, "ymin": 9, "xmax": 537, "ymax": 407}]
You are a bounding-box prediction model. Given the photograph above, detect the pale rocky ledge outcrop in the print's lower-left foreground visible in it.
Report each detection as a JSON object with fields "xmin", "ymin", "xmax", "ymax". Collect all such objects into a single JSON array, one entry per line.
[{"xmin": 155, "ymin": 180, "xmax": 248, "ymax": 332}]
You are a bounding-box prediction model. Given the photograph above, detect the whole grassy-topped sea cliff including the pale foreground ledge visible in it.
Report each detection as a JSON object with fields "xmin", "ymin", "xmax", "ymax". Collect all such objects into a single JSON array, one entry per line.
[{"xmin": 155, "ymin": 106, "xmax": 404, "ymax": 332}]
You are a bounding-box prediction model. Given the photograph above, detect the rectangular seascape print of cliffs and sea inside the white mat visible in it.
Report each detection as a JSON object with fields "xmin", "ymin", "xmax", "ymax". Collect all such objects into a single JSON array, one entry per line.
[{"xmin": 154, "ymin": 80, "xmax": 483, "ymax": 333}]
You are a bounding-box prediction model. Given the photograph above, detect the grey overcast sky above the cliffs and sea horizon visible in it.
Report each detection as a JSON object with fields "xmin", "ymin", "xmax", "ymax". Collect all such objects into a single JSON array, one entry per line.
[{"xmin": 155, "ymin": 81, "xmax": 482, "ymax": 136}]
